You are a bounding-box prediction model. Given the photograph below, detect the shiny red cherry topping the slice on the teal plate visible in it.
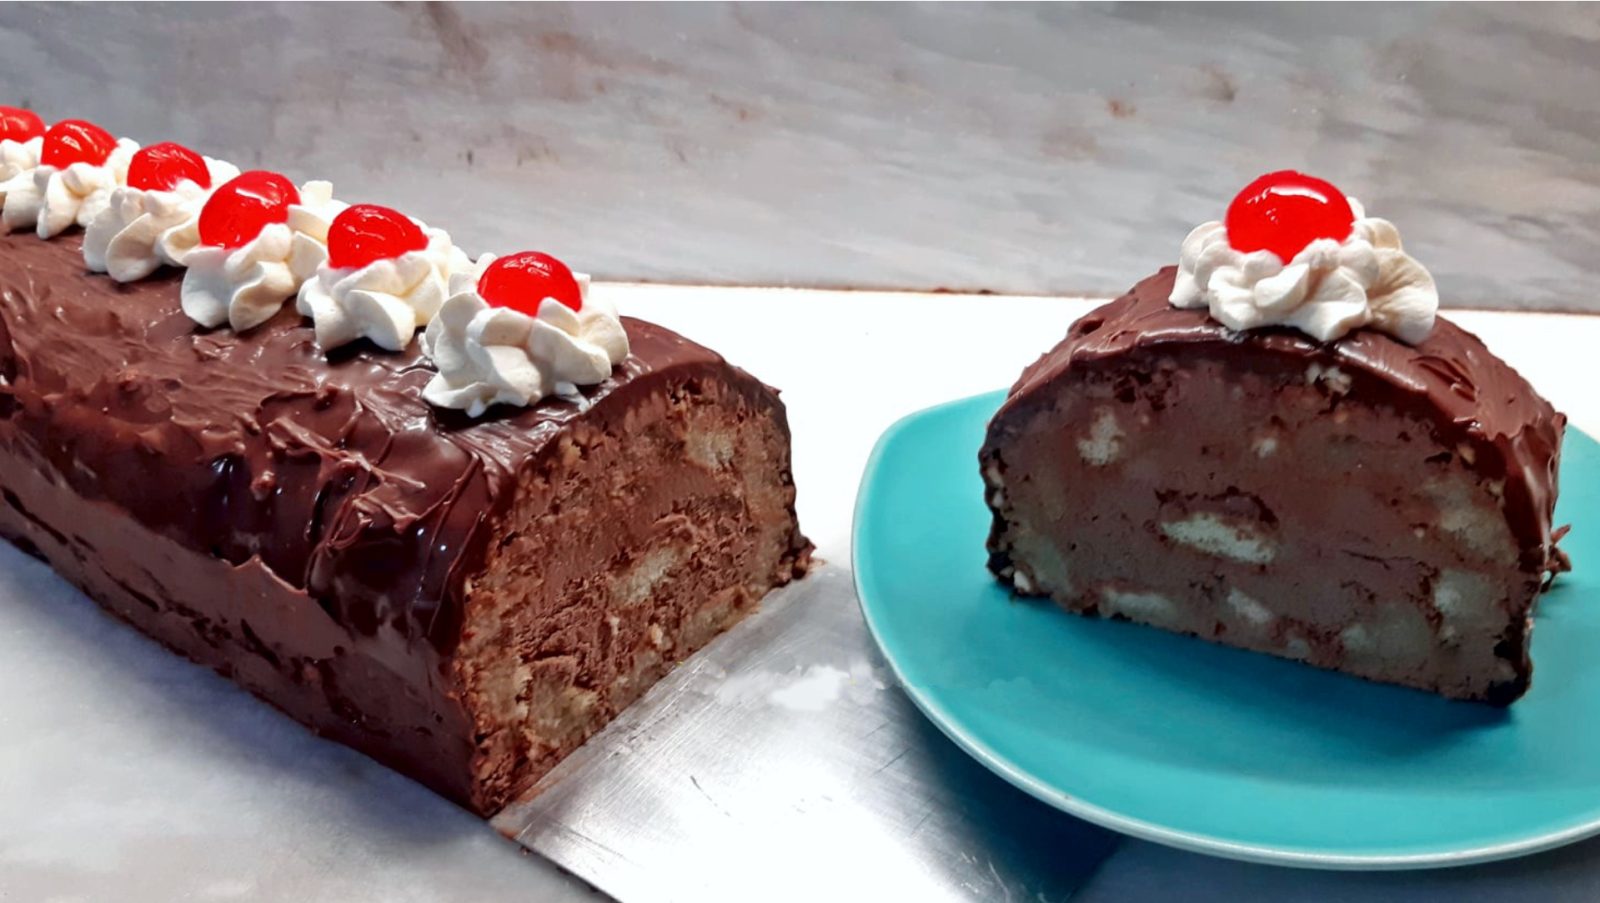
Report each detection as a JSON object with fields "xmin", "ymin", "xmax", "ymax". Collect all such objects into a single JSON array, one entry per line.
[{"xmin": 1226, "ymin": 170, "xmax": 1355, "ymax": 263}]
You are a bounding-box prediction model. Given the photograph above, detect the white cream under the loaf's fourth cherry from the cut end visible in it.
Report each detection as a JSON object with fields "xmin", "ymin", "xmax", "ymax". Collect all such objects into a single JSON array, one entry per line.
[{"xmin": 83, "ymin": 157, "xmax": 238, "ymax": 282}]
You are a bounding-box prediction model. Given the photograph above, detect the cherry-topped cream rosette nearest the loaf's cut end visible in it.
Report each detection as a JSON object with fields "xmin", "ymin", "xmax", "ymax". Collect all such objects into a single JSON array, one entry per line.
[{"xmin": 422, "ymin": 251, "xmax": 629, "ymax": 418}]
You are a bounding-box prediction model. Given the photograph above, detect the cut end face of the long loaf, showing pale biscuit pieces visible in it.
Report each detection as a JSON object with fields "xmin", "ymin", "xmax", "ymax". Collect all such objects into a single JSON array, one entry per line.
[{"xmin": 454, "ymin": 369, "xmax": 811, "ymax": 812}]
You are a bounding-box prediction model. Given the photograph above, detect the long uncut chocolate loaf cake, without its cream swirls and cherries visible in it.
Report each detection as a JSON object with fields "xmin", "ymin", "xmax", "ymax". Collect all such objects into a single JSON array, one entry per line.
[{"xmin": 0, "ymin": 224, "xmax": 810, "ymax": 813}]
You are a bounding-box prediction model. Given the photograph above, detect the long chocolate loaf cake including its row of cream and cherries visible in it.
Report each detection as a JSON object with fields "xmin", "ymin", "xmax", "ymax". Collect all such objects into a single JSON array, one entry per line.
[{"xmin": 0, "ymin": 118, "xmax": 811, "ymax": 813}]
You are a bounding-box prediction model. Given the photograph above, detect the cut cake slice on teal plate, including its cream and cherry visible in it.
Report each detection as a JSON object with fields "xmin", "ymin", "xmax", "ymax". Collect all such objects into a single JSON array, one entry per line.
[{"xmin": 981, "ymin": 173, "xmax": 1565, "ymax": 704}]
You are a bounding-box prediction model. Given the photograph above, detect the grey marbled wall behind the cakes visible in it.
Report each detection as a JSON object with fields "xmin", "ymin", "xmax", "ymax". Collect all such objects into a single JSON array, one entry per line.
[{"xmin": 0, "ymin": 3, "xmax": 1600, "ymax": 311}]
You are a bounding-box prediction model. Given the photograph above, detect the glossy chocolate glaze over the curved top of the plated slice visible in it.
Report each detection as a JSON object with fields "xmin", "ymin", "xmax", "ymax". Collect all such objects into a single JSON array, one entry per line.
[{"xmin": 995, "ymin": 267, "xmax": 1566, "ymax": 573}]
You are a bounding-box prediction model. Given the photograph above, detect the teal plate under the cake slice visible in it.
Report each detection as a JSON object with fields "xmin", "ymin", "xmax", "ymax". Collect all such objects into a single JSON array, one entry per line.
[{"xmin": 854, "ymin": 392, "xmax": 1600, "ymax": 869}]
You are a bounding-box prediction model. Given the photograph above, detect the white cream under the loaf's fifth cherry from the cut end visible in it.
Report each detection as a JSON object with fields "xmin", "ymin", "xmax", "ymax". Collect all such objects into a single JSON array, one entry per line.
[{"xmin": 0, "ymin": 138, "xmax": 139, "ymax": 239}]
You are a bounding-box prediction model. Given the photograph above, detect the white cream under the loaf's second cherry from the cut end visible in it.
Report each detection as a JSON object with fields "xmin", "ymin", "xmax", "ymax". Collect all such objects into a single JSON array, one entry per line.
[{"xmin": 294, "ymin": 227, "xmax": 474, "ymax": 352}]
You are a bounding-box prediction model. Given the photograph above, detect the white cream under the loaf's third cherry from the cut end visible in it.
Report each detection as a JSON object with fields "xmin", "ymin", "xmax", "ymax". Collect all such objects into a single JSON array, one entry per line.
[{"xmin": 182, "ymin": 183, "xmax": 346, "ymax": 331}]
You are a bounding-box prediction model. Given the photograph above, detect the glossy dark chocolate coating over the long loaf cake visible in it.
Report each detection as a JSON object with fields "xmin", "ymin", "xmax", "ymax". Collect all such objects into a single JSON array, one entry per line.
[{"xmin": 0, "ymin": 227, "xmax": 810, "ymax": 813}]
